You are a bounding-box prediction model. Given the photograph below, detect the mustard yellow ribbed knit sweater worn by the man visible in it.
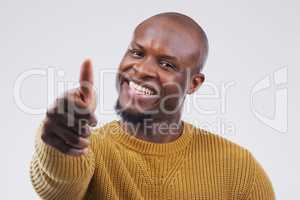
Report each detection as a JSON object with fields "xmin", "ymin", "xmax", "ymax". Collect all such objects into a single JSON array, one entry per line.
[{"xmin": 30, "ymin": 121, "xmax": 275, "ymax": 200}]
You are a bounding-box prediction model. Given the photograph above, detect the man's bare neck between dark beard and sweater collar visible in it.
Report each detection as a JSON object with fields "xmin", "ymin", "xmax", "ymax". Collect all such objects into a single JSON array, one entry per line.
[{"xmin": 121, "ymin": 113, "xmax": 182, "ymax": 143}]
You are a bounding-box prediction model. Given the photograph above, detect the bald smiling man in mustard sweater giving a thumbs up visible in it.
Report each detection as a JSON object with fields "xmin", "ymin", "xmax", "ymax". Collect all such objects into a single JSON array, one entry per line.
[{"xmin": 30, "ymin": 13, "xmax": 275, "ymax": 200}]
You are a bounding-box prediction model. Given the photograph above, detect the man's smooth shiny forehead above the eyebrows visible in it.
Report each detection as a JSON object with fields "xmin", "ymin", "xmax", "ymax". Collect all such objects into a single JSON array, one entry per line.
[{"xmin": 133, "ymin": 20, "xmax": 200, "ymax": 65}]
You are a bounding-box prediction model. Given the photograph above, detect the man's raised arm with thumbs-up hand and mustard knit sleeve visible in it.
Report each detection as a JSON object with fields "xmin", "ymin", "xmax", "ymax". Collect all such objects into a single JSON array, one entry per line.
[{"xmin": 30, "ymin": 60, "xmax": 96, "ymax": 200}]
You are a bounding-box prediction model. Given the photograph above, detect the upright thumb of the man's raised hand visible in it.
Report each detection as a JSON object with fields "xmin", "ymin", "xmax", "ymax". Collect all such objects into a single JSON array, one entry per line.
[{"xmin": 79, "ymin": 59, "xmax": 94, "ymax": 101}]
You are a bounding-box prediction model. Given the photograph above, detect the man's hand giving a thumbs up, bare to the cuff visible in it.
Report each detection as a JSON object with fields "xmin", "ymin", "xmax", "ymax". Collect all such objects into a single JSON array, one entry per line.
[{"xmin": 41, "ymin": 60, "xmax": 97, "ymax": 156}]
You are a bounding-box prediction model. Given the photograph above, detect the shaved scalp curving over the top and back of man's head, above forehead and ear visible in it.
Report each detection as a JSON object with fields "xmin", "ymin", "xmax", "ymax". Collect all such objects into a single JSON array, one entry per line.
[{"xmin": 135, "ymin": 12, "xmax": 208, "ymax": 72}]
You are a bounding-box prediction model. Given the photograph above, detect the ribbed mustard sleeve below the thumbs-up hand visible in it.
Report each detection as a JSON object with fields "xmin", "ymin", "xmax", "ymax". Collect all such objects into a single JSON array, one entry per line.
[{"xmin": 30, "ymin": 124, "xmax": 95, "ymax": 200}]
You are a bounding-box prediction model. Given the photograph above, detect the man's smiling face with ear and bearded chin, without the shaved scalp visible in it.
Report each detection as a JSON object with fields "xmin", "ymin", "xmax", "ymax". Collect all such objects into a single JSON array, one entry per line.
[{"xmin": 117, "ymin": 13, "xmax": 204, "ymax": 122}]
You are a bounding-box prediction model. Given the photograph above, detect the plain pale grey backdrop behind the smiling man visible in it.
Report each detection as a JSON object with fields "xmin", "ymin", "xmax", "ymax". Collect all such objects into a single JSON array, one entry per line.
[{"xmin": 0, "ymin": 0, "xmax": 300, "ymax": 199}]
